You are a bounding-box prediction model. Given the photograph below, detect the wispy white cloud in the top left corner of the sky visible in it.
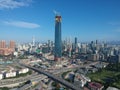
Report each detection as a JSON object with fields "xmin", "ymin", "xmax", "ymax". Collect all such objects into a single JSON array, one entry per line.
[{"xmin": 0, "ymin": 0, "xmax": 32, "ymax": 9}]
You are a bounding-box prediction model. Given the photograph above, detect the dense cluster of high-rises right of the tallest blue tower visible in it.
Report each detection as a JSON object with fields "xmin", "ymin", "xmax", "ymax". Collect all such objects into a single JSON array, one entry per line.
[{"xmin": 63, "ymin": 38, "xmax": 120, "ymax": 63}]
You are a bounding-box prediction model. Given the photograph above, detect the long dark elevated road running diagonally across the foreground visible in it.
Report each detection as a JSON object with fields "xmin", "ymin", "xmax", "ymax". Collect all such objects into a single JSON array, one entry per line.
[{"xmin": 20, "ymin": 63, "xmax": 81, "ymax": 90}]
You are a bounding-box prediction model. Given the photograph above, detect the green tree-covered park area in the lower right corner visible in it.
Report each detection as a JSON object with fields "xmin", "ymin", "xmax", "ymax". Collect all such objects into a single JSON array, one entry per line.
[{"xmin": 88, "ymin": 63, "xmax": 120, "ymax": 88}]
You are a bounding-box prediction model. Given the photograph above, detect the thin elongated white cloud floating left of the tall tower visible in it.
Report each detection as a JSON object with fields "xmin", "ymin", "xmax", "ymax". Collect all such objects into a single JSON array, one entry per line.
[{"xmin": 3, "ymin": 21, "xmax": 40, "ymax": 29}]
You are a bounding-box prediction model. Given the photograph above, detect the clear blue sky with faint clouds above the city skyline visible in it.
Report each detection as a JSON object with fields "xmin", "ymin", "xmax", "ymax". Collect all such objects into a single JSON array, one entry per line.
[{"xmin": 0, "ymin": 0, "xmax": 120, "ymax": 42}]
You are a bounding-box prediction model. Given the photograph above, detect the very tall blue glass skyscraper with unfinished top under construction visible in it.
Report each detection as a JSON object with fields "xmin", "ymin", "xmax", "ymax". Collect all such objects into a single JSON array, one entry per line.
[{"xmin": 54, "ymin": 15, "xmax": 62, "ymax": 60}]
